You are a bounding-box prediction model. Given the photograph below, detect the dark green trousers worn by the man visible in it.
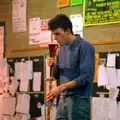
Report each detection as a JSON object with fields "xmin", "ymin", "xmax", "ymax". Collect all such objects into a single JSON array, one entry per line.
[{"xmin": 56, "ymin": 95, "xmax": 90, "ymax": 120}]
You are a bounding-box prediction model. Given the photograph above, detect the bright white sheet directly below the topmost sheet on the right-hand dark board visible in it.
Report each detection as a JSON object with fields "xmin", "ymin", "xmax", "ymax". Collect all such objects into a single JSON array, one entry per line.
[{"xmin": 107, "ymin": 68, "xmax": 118, "ymax": 87}]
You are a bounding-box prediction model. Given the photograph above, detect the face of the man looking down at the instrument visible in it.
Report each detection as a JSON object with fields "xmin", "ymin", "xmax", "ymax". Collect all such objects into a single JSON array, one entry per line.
[{"xmin": 52, "ymin": 28, "xmax": 70, "ymax": 46}]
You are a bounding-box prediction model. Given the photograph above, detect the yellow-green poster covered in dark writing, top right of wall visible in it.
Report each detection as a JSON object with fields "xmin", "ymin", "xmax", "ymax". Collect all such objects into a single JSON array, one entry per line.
[{"xmin": 83, "ymin": 0, "xmax": 120, "ymax": 26}]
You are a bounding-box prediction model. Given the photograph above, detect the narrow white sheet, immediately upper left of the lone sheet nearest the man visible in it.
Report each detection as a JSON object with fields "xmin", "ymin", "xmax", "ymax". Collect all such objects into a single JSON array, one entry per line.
[{"xmin": 25, "ymin": 60, "xmax": 33, "ymax": 80}]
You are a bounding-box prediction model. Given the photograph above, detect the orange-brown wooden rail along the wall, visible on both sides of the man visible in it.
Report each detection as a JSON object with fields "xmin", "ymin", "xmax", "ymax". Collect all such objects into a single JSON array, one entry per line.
[{"xmin": 12, "ymin": 40, "xmax": 120, "ymax": 53}]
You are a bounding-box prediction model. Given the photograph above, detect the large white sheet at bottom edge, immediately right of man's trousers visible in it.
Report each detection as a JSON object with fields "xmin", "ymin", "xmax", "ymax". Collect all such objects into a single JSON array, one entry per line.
[{"xmin": 92, "ymin": 97, "xmax": 109, "ymax": 120}]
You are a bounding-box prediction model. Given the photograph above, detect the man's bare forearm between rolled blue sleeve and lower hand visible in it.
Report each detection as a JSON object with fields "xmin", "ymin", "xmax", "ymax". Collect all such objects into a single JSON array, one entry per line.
[{"xmin": 59, "ymin": 80, "xmax": 77, "ymax": 92}]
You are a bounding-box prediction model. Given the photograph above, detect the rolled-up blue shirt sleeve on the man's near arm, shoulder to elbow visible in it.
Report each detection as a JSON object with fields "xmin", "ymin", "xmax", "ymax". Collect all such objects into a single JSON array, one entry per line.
[{"xmin": 74, "ymin": 44, "xmax": 95, "ymax": 86}]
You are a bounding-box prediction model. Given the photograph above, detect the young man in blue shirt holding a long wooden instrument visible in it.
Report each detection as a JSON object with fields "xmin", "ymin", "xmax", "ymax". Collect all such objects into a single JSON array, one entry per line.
[{"xmin": 47, "ymin": 14, "xmax": 95, "ymax": 120}]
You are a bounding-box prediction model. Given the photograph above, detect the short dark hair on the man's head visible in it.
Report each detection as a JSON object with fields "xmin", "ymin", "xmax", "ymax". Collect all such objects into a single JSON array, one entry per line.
[{"xmin": 48, "ymin": 14, "xmax": 73, "ymax": 34}]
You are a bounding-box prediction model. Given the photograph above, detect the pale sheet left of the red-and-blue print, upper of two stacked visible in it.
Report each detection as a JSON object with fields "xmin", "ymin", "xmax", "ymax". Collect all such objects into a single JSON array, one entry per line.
[{"xmin": 29, "ymin": 17, "xmax": 41, "ymax": 34}]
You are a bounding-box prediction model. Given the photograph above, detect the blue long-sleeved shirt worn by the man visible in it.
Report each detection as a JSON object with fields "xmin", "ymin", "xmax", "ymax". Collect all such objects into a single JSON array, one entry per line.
[{"xmin": 54, "ymin": 36, "xmax": 95, "ymax": 97}]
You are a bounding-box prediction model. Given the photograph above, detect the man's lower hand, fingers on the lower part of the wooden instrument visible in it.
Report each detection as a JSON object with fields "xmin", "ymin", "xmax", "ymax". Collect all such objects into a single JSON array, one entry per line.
[{"xmin": 47, "ymin": 86, "xmax": 61, "ymax": 102}]
